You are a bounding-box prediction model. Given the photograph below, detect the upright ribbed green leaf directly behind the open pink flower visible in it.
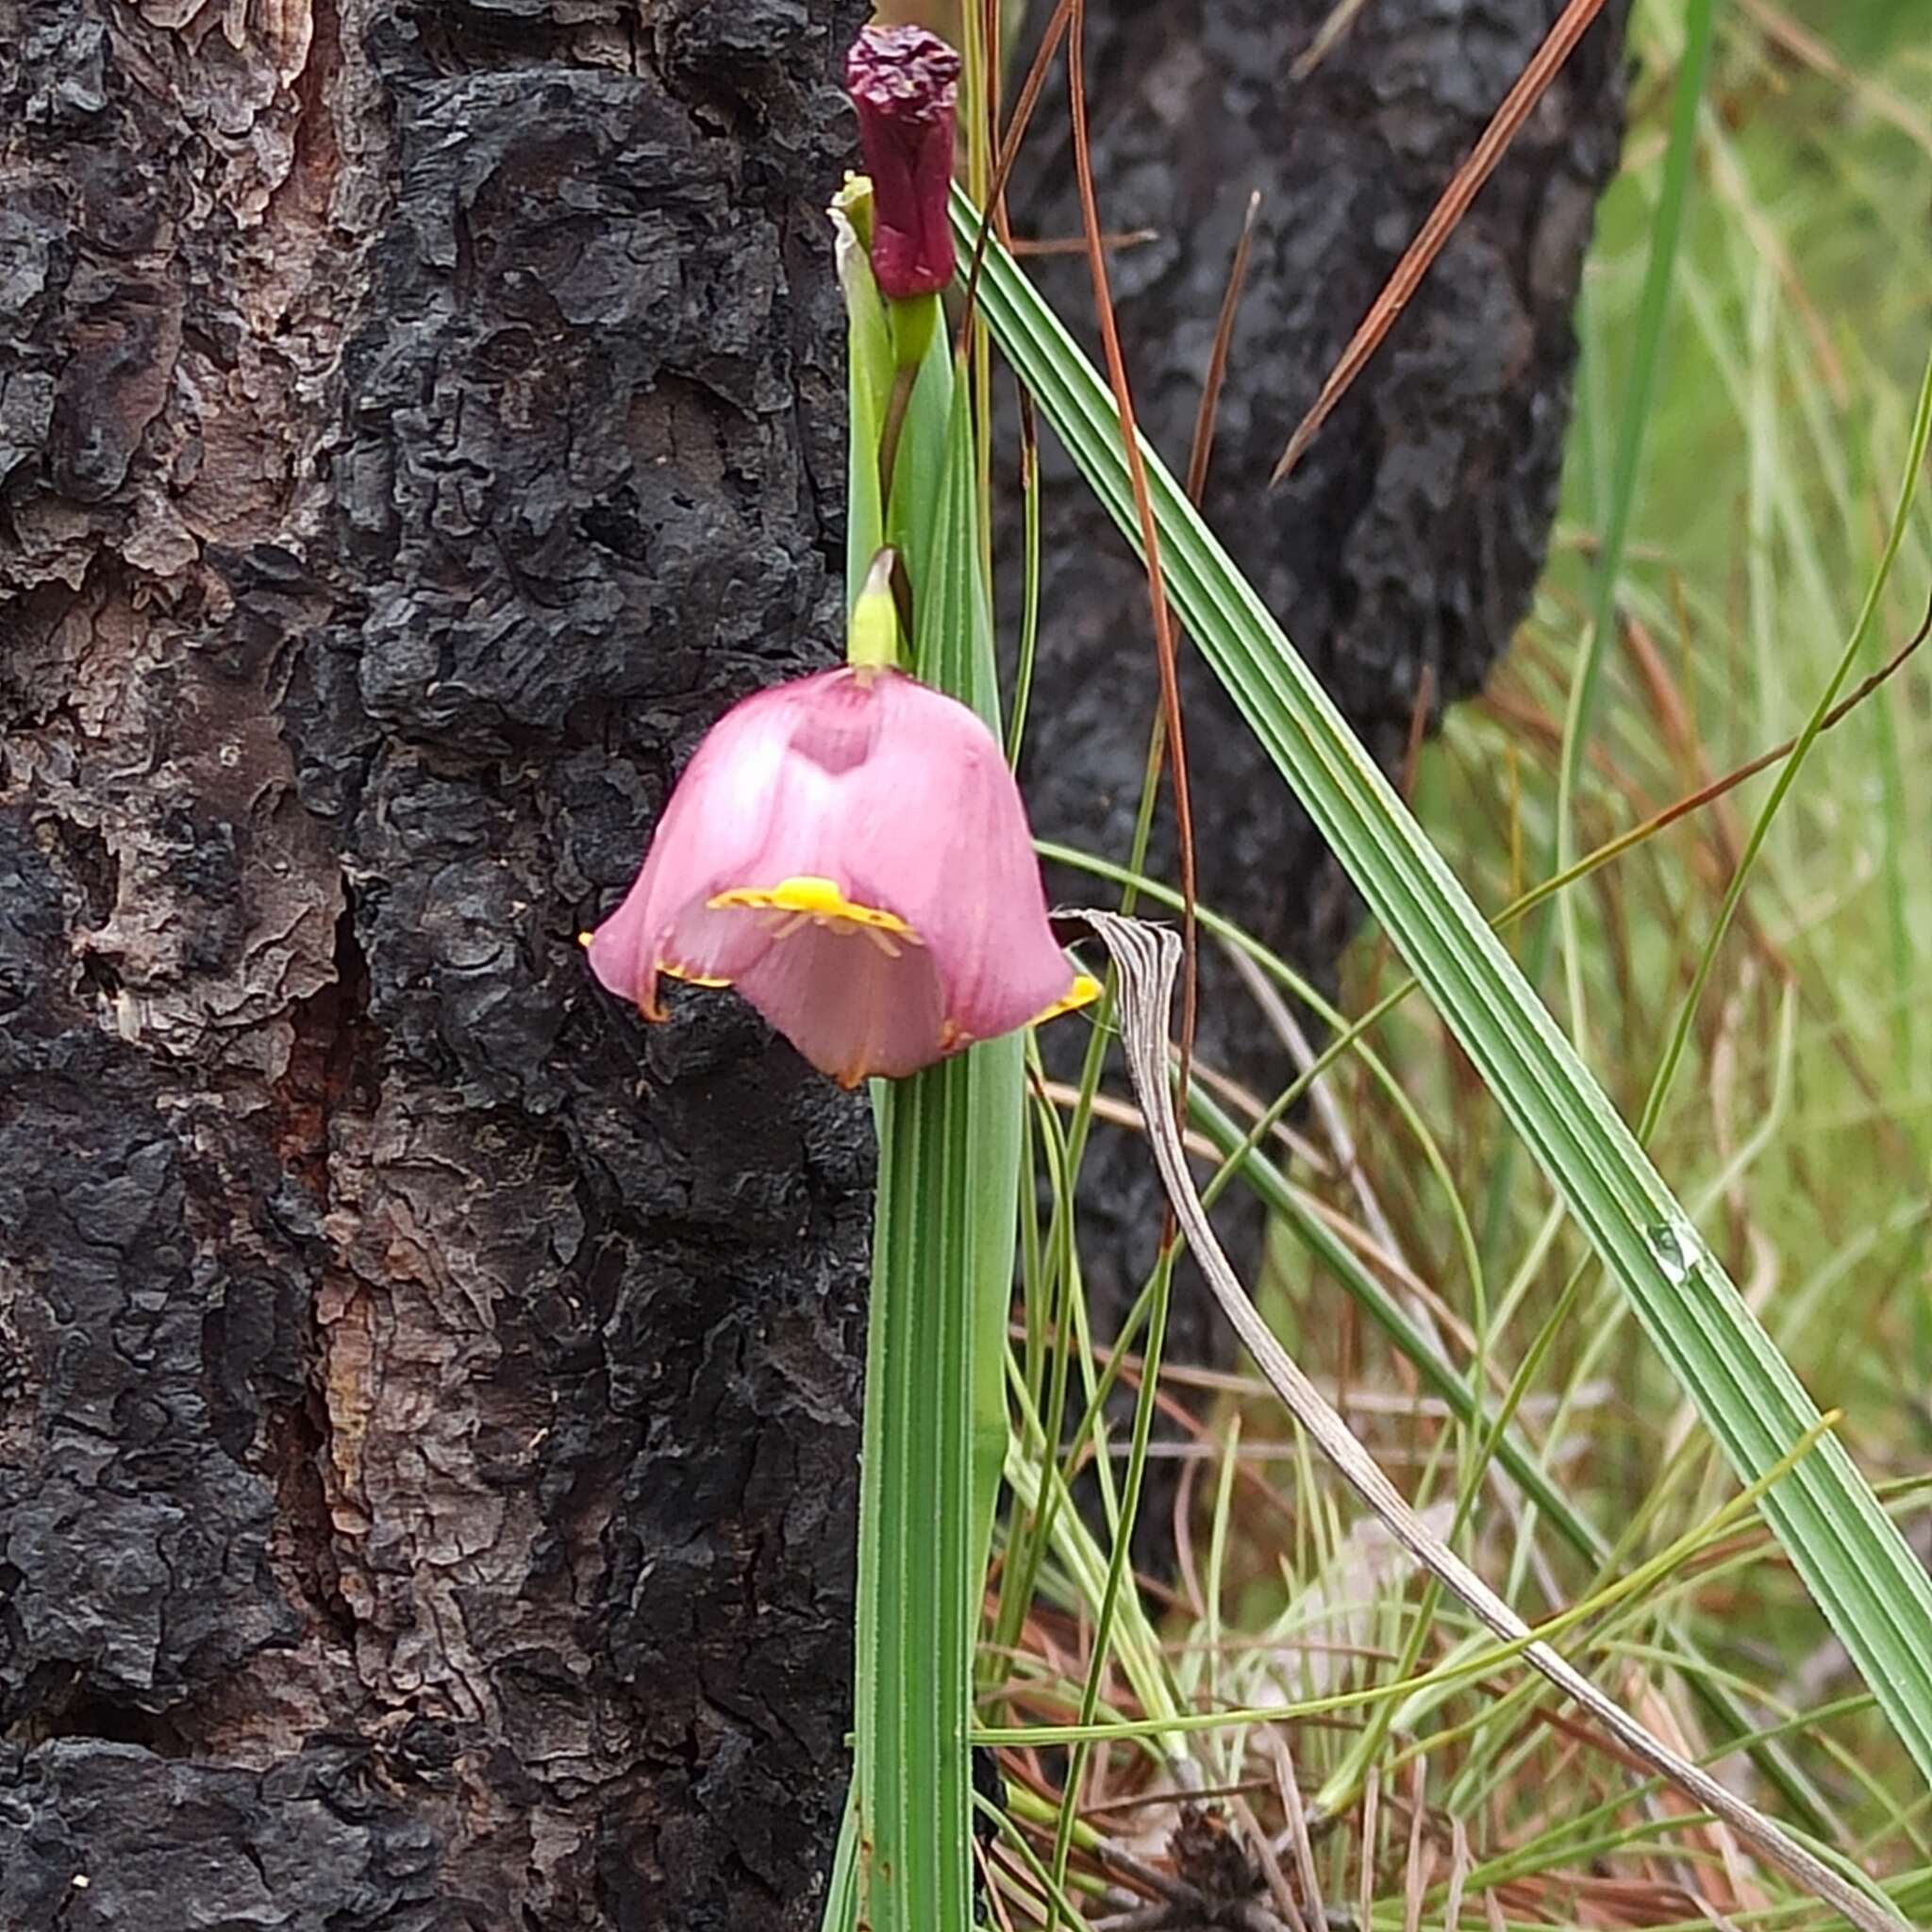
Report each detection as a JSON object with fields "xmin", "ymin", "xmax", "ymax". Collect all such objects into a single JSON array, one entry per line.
[{"xmin": 841, "ymin": 316, "xmax": 1024, "ymax": 1932}]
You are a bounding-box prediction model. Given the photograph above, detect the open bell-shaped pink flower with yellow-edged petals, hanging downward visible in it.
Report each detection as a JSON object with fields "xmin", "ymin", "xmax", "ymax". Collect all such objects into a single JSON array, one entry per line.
[{"xmin": 588, "ymin": 665, "xmax": 1099, "ymax": 1086}]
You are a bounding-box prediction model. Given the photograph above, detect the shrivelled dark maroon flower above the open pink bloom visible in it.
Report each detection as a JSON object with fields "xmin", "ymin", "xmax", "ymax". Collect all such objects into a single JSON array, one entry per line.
[{"xmin": 846, "ymin": 27, "xmax": 960, "ymax": 299}]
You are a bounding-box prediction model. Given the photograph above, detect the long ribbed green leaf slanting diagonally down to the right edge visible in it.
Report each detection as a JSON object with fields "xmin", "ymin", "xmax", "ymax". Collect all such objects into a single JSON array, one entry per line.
[{"xmin": 955, "ymin": 195, "xmax": 1932, "ymax": 1781}]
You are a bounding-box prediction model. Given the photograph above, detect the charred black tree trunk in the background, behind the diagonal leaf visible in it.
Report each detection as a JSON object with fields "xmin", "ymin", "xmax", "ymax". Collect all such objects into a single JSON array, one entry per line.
[{"xmin": 1005, "ymin": 0, "xmax": 1626, "ymax": 1391}]
